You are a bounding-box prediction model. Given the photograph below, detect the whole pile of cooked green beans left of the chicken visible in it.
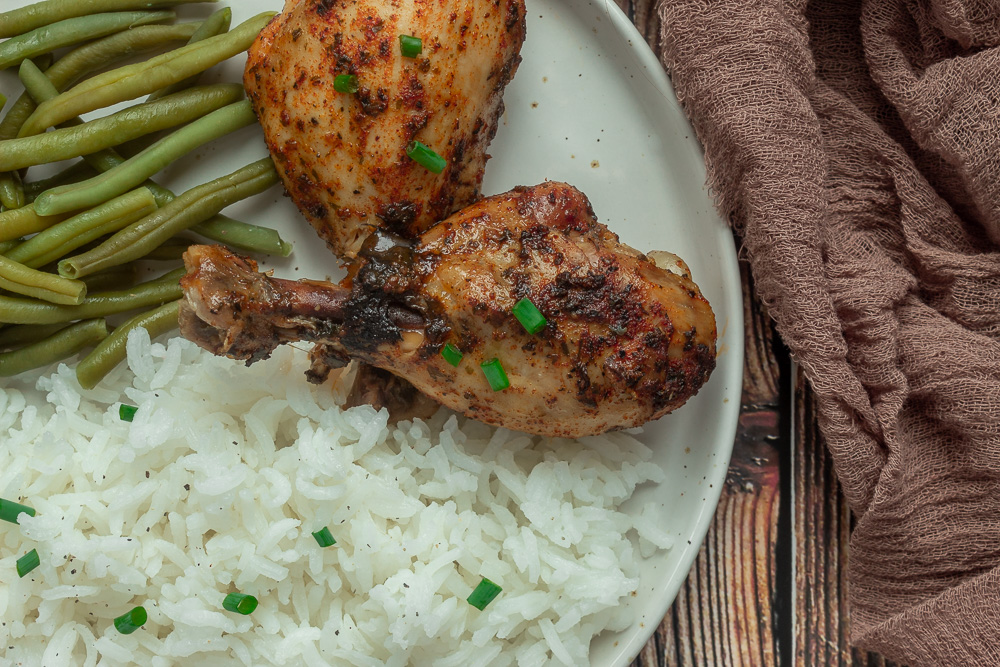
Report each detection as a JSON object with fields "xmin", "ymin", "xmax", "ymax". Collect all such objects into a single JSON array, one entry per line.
[{"xmin": 0, "ymin": 0, "xmax": 291, "ymax": 389}]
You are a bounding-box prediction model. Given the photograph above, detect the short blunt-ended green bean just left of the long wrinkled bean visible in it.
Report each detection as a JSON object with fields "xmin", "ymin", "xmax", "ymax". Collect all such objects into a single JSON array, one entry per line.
[{"xmin": 7, "ymin": 188, "xmax": 156, "ymax": 268}]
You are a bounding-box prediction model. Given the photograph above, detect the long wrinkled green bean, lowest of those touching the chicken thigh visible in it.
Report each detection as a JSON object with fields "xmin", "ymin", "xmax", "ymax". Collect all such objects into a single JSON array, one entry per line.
[{"xmin": 59, "ymin": 158, "xmax": 278, "ymax": 278}]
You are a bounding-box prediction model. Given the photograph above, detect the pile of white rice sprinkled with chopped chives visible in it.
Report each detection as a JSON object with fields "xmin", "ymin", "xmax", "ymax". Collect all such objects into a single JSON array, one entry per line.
[{"xmin": 0, "ymin": 330, "xmax": 671, "ymax": 667}]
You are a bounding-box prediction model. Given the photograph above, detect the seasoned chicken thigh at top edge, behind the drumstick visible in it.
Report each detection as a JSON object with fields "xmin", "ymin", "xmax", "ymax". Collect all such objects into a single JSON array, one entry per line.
[{"xmin": 244, "ymin": 0, "xmax": 525, "ymax": 258}]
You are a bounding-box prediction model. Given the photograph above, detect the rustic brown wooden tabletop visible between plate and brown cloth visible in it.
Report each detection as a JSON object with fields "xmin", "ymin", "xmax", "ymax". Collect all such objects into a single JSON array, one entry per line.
[{"xmin": 615, "ymin": 0, "xmax": 893, "ymax": 667}]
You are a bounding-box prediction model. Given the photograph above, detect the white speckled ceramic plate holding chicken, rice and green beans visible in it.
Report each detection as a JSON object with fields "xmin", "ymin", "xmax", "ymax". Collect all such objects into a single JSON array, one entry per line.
[{"xmin": 0, "ymin": 0, "xmax": 743, "ymax": 666}]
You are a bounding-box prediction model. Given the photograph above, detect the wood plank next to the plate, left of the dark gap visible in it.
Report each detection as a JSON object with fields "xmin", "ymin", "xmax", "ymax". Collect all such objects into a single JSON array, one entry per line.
[{"xmin": 633, "ymin": 264, "xmax": 787, "ymax": 667}]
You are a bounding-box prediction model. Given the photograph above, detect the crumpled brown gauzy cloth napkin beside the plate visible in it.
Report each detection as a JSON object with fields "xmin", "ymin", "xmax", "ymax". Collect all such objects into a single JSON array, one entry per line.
[{"xmin": 659, "ymin": 0, "xmax": 1000, "ymax": 665}]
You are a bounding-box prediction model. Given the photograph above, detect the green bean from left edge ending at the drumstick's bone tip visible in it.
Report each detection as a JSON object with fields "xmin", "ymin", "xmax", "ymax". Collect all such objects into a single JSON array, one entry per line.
[{"xmin": 0, "ymin": 269, "xmax": 184, "ymax": 324}]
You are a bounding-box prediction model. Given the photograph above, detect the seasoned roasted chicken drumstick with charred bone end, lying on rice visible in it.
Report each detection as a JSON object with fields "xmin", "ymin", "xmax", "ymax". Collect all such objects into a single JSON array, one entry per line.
[{"xmin": 181, "ymin": 183, "xmax": 716, "ymax": 437}]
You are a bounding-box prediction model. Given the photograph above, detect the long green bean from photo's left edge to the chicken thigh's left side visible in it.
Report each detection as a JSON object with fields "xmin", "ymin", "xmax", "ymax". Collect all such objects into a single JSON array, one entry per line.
[{"xmin": 0, "ymin": 80, "xmax": 243, "ymax": 171}]
